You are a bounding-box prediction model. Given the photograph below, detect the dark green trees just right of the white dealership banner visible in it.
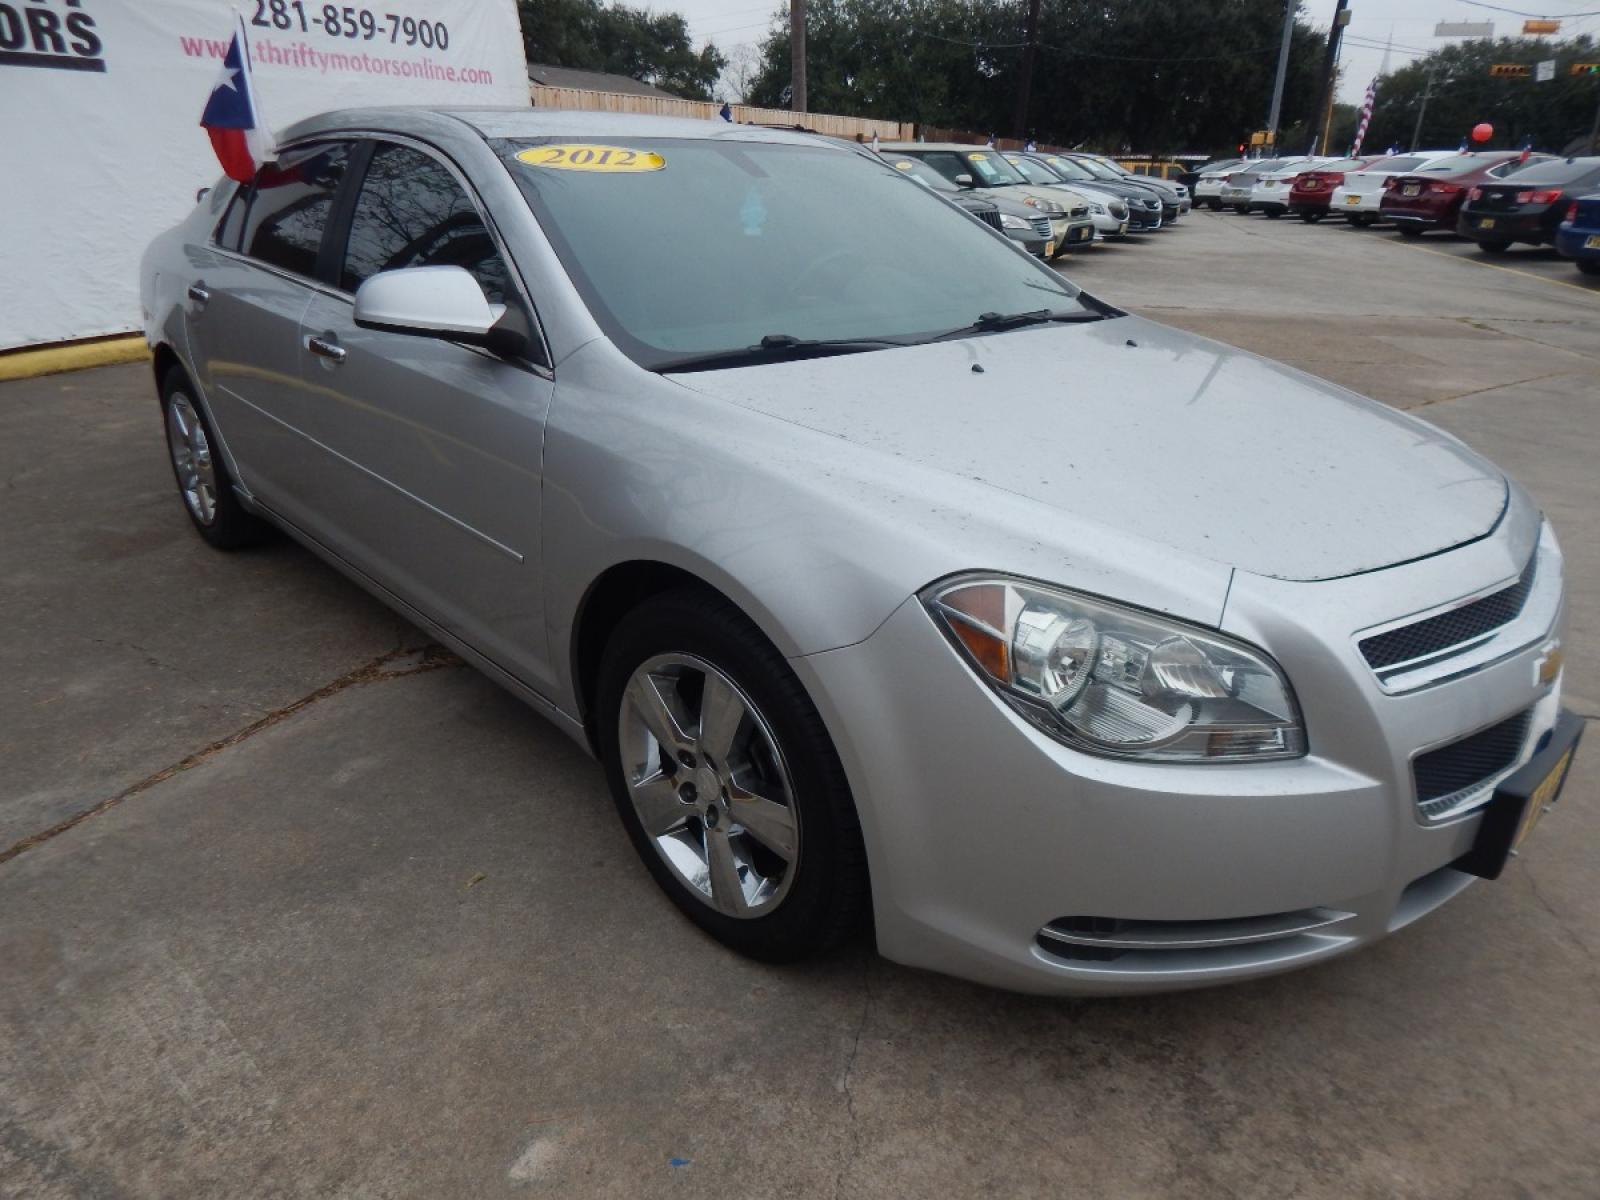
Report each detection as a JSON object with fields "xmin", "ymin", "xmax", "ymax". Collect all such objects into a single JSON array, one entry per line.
[{"xmin": 517, "ymin": 0, "xmax": 726, "ymax": 99}]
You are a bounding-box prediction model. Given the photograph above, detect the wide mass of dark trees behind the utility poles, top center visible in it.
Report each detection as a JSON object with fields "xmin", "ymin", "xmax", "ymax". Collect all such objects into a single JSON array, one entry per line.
[{"xmin": 750, "ymin": 0, "xmax": 1325, "ymax": 152}]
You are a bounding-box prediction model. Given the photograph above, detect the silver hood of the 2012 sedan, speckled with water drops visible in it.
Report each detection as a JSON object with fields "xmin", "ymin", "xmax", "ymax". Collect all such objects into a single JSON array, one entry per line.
[{"xmin": 674, "ymin": 317, "xmax": 1507, "ymax": 579}]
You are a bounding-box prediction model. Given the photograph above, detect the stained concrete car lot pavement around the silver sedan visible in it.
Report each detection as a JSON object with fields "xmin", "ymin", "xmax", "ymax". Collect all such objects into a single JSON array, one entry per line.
[{"xmin": 0, "ymin": 214, "xmax": 1600, "ymax": 1197}]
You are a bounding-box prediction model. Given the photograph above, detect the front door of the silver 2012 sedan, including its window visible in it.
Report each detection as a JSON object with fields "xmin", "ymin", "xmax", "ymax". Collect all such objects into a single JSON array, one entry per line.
[{"xmin": 299, "ymin": 139, "xmax": 555, "ymax": 686}]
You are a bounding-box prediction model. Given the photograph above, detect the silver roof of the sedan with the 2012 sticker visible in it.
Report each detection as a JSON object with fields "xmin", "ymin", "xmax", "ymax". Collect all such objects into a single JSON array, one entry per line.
[{"xmin": 283, "ymin": 106, "xmax": 846, "ymax": 152}]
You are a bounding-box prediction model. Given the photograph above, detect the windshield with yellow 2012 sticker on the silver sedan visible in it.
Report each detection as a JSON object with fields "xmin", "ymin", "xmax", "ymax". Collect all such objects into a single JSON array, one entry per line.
[{"xmin": 493, "ymin": 138, "xmax": 1104, "ymax": 370}]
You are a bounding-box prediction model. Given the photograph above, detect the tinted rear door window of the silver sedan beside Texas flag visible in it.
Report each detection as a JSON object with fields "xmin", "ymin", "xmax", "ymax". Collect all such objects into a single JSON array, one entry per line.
[{"xmin": 243, "ymin": 142, "xmax": 350, "ymax": 277}]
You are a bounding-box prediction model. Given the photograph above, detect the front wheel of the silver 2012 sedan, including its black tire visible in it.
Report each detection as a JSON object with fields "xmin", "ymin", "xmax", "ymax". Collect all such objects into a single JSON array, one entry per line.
[{"xmin": 595, "ymin": 587, "xmax": 869, "ymax": 963}]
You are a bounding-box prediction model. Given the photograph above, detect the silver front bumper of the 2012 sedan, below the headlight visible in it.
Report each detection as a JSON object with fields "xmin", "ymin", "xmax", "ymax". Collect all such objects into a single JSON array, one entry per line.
[{"xmin": 794, "ymin": 508, "xmax": 1562, "ymax": 994}]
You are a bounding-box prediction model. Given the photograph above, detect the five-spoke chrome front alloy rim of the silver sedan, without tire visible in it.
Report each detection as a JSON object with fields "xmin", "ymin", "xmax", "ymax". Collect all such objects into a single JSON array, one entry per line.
[{"xmin": 618, "ymin": 654, "xmax": 800, "ymax": 918}]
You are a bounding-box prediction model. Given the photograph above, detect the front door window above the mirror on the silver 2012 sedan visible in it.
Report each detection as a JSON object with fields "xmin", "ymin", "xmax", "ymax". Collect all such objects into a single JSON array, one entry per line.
[{"xmin": 339, "ymin": 142, "xmax": 509, "ymax": 304}]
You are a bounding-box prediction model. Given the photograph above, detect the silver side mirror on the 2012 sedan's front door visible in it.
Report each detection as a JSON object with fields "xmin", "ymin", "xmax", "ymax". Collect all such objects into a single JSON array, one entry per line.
[{"xmin": 355, "ymin": 267, "xmax": 528, "ymax": 355}]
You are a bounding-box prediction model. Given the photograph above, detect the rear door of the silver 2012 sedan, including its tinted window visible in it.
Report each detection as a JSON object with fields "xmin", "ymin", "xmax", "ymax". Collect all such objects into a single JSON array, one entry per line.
[{"xmin": 187, "ymin": 141, "xmax": 352, "ymax": 515}]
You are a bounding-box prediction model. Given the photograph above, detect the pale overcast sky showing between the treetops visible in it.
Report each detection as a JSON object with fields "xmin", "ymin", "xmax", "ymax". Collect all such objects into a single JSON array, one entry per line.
[{"xmin": 656, "ymin": 0, "xmax": 1600, "ymax": 110}]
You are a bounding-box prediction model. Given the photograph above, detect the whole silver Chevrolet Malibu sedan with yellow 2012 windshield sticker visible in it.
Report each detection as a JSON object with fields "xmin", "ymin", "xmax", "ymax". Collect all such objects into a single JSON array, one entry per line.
[{"xmin": 141, "ymin": 109, "xmax": 1581, "ymax": 994}]
